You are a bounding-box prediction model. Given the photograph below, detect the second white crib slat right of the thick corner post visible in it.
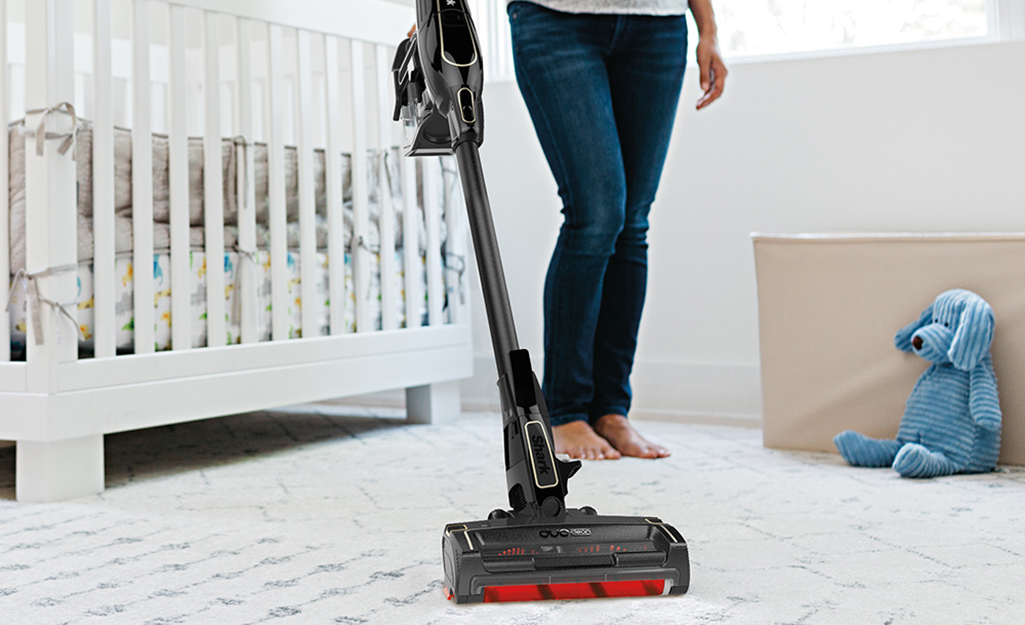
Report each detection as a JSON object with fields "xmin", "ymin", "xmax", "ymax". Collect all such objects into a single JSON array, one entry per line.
[{"xmin": 131, "ymin": 0, "xmax": 154, "ymax": 353}]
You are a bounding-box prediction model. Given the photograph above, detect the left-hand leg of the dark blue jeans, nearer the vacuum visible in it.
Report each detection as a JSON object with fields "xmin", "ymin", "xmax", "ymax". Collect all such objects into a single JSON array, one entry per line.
[{"xmin": 509, "ymin": 2, "xmax": 626, "ymax": 425}]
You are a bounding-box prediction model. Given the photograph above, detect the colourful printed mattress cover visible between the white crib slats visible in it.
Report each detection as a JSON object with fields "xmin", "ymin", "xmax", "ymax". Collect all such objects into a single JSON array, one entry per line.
[{"xmin": 10, "ymin": 250, "xmax": 427, "ymax": 355}]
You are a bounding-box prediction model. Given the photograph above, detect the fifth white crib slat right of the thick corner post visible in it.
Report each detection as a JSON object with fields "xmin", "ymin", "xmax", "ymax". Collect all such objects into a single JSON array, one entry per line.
[{"xmin": 235, "ymin": 18, "xmax": 259, "ymax": 343}]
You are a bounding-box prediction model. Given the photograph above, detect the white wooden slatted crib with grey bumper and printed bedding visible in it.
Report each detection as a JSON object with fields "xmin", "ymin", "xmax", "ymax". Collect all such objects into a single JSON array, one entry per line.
[{"xmin": 0, "ymin": 0, "xmax": 473, "ymax": 501}]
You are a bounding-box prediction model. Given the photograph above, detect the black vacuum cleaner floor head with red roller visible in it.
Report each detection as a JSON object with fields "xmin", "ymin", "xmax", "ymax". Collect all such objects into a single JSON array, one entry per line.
[{"xmin": 442, "ymin": 508, "xmax": 690, "ymax": 603}]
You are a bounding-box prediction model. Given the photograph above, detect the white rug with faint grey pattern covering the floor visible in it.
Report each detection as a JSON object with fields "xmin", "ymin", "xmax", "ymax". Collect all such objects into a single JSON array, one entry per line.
[{"xmin": 0, "ymin": 407, "xmax": 1025, "ymax": 625}]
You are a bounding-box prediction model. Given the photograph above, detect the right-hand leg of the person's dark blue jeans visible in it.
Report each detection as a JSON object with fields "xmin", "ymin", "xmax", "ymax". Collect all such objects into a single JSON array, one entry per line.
[{"xmin": 589, "ymin": 15, "xmax": 687, "ymax": 421}]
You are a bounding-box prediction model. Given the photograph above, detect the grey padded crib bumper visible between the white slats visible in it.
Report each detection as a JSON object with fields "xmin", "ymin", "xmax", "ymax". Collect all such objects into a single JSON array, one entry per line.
[{"xmin": 8, "ymin": 120, "xmax": 447, "ymax": 273}]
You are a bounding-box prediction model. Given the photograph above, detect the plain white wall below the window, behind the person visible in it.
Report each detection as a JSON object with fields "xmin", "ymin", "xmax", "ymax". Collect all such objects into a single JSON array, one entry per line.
[{"xmin": 463, "ymin": 43, "xmax": 1025, "ymax": 423}]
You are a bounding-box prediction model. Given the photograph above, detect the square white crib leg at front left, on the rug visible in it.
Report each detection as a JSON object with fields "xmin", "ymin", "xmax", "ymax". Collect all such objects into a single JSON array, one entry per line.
[{"xmin": 14, "ymin": 434, "xmax": 104, "ymax": 503}]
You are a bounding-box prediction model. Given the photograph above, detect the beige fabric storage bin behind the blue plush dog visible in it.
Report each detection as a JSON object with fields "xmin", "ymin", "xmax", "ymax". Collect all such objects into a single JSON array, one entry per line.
[{"xmin": 752, "ymin": 234, "xmax": 1025, "ymax": 464}]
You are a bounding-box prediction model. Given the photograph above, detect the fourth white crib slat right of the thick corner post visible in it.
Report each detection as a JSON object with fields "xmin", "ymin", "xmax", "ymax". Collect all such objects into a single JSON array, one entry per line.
[{"xmin": 203, "ymin": 11, "xmax": 228, "ymax": 347}]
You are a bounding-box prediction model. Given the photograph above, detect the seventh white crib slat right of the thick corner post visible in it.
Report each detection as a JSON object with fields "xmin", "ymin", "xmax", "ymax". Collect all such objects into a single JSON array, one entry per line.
[{"xmin": 292, "ymin": 31, "xmax": 318, "ymax": 337}]
